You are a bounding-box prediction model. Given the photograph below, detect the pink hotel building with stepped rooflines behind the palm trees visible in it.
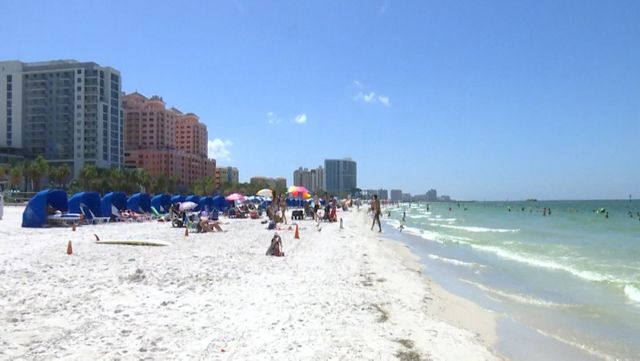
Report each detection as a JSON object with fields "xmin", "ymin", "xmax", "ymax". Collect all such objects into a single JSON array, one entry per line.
[{"xmin": 123, "ymin": 92, "xmax": 216, "ymax": 186}]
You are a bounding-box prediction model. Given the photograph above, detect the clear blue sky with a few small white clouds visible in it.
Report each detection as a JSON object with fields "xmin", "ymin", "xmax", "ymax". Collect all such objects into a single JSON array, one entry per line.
[{"xmin": 0, "ymin": 0, "xmax": 640, "ymax": 200}]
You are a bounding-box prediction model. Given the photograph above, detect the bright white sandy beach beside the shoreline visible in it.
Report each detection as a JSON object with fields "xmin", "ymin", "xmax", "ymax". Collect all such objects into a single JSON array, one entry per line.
[{"xmin": 0, "ymin": 207, "xmax": 500, "ymax": 360}]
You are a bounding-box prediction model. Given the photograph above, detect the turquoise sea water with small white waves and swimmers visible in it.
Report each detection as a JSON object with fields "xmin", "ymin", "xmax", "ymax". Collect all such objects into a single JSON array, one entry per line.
[{"xmin": 385, "ymin": 201, "xmax": 640, "ymax": 360}]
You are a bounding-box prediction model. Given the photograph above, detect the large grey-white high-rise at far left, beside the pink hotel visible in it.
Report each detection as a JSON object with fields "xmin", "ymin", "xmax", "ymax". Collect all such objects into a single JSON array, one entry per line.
[{"xmin": 0, "ymin": 60, "xmax": 124, "ymax": 175}]
